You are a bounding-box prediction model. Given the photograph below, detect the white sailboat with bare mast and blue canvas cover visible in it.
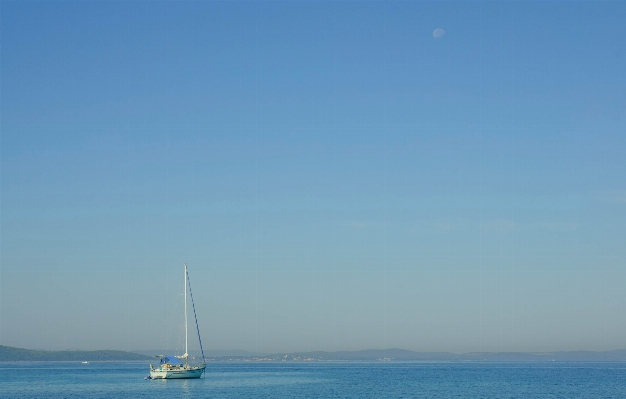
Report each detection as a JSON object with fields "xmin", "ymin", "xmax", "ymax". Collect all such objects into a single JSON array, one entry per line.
[{"xmin": 150, "ymin": 263, "xmax": 206, "ymax": 379}]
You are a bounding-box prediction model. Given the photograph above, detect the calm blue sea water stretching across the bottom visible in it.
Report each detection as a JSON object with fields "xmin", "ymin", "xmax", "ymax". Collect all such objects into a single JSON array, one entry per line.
[{"xmin": 0, "ymin": 362, "xmax": 626, "ymax": 399}]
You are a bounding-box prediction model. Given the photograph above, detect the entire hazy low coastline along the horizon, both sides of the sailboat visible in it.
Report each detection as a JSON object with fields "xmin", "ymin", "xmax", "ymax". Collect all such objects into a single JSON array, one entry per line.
[{"xmin": 0, "ymin": 345, "xmax": 626, "ymax": 362}]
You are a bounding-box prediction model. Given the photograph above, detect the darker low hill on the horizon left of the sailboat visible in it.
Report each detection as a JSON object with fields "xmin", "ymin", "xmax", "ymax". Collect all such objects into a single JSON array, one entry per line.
[{"xmin": 0, "ymin": 345, "xmax": 154, "ymax": 362}]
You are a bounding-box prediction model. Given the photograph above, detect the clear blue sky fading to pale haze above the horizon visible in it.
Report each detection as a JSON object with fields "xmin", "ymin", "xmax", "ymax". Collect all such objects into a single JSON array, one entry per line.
[{"xmin": 0, "ymin": 1, "xmax": 626, "ymax": 352}]
